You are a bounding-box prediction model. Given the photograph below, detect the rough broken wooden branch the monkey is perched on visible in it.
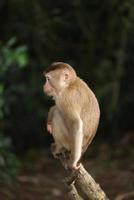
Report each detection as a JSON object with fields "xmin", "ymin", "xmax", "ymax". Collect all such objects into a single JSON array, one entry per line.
[{"xmin": 51, "ymin": 149, "xmax": 108, "ymax": 200}]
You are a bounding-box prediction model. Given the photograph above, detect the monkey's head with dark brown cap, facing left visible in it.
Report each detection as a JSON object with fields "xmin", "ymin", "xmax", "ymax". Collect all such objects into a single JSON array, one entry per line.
[{"xmin": 43, "ymin": 62, "xmax": 76, "ymax": 97}]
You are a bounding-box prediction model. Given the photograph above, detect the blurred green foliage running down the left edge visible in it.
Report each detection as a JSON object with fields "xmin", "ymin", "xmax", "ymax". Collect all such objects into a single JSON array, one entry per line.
[{"xmin": 0, "ymin": 38, "xmax": 28, "ymax": 181}]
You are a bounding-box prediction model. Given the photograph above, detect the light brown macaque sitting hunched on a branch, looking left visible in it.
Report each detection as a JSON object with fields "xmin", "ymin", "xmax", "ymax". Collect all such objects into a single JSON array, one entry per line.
[{"xmin": 43, "ymin": 62, "xmax": 100, "ymax": 170}]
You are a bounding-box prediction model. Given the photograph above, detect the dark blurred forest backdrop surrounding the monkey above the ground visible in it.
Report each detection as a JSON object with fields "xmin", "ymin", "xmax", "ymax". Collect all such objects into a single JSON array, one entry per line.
[{"xmin": 0, "ymin": 0, "xmax": 134, "ymax": 200}]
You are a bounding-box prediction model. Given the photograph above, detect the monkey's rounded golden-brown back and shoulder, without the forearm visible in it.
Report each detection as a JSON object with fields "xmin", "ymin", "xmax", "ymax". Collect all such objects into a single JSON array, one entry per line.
[{"xmin": 56, "ymin": 77, "xmax": 100, "ymax": 152}]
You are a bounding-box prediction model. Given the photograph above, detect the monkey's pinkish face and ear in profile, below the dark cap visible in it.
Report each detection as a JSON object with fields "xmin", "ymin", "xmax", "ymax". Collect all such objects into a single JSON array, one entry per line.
[{"xmin": 43, "ymin": 70, "xmax": 68, "ymax": 97}]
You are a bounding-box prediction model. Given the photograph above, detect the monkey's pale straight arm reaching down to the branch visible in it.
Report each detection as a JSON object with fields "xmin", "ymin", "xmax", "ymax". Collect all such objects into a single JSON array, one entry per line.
[{"xmin": 64, "ymin": 102, "xmax": 83, "ymax": 169}]
